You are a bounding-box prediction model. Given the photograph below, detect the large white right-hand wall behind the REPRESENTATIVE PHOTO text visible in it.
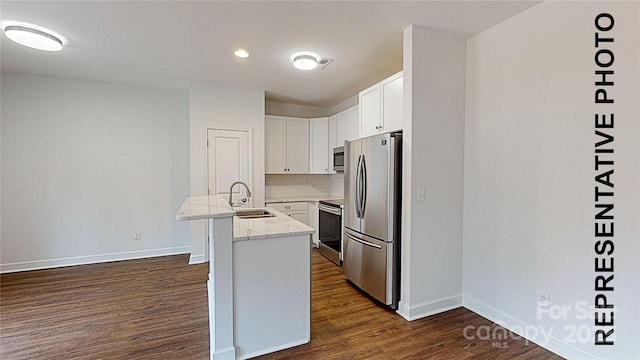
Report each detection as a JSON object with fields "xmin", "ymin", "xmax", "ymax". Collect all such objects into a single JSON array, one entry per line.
[{"xmin": 463, "ymin": 2, "xmax": 640, "ymax": 359}]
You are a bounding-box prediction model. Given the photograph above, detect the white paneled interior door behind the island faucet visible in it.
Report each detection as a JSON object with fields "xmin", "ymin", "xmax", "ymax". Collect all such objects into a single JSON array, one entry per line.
[{"xmin": 207, "ymin": 129, "xmax": 253, "ymax": 207}]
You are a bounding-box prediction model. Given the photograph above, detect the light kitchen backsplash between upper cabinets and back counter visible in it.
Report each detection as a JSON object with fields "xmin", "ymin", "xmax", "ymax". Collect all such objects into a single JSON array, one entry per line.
[{"xmin": 265, "ymin": 174, "xmax": 344, "ymax": 200}]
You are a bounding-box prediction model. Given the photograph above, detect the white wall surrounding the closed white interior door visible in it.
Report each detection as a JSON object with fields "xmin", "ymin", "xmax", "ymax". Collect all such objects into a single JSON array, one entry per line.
[{"xmin": 189, "ymin": 82, "xmax": 265, "ymax": 263}]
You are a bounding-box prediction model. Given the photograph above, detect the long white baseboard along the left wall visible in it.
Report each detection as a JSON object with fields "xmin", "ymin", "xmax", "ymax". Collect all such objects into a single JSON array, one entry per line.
[{"xmin": 0, "ymin": 246, "xmax": 191, "ymax": 274}]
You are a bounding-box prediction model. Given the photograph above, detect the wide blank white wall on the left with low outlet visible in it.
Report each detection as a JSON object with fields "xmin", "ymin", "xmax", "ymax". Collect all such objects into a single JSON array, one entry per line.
[{"xmin": 0, "ymin": 73, "xmax": 189, "ymax": 272}]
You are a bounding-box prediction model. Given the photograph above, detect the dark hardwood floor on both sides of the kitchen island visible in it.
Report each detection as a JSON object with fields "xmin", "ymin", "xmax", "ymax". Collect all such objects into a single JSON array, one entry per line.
[{"xmin": 0, "ymin": 251, "xmax": 561, "ymax": 360}]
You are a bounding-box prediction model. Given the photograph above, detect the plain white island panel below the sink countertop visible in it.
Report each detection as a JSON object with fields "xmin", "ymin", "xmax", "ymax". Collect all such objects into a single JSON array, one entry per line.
[{"xmin": 234, "ymin": 235, "xmax": 311, "ymax": 359}]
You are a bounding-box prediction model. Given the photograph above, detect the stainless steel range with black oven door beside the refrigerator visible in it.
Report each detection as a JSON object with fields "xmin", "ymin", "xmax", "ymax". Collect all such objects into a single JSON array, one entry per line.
[{"xmin": 318, "ymin": 199, "xmax": 344, "ymax": 266}]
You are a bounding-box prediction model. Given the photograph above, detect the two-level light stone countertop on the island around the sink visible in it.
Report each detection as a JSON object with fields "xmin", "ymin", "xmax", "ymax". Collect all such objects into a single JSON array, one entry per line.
[{"xmin": 176, "ymin": 195, "xmax": 315, "ymax": 241}]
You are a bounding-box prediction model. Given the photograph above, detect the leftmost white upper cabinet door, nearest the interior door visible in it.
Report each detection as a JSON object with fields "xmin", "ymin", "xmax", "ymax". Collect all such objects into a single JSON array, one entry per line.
[{"xmin": 265, "ymin": 116, "xmax": 287, "ymax": 174}]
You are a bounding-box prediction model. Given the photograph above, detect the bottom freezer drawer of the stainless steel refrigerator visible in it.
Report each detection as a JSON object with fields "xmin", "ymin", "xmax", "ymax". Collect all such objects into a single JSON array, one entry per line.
[{"xmin": 342, "ymin": 228, "xmax": 395, "ymax": 306}]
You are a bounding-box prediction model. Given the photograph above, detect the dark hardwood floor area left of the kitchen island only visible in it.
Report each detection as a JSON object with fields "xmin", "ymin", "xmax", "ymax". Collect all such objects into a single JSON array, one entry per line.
[{"xmin": 0, "ymin": 255, "xmax": 209, "ymax": 360}]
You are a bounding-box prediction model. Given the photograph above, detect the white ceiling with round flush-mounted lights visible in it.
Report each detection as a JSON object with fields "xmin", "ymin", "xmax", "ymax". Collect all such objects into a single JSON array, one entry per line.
[{"xmin": 0, "ymin": 0, "xmax": 538, "ymax": 107}]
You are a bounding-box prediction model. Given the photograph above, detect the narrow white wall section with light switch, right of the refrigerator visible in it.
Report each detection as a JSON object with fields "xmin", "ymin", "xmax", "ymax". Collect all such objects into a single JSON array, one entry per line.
[{"xmin": 398, "ymin": 25, "xmax": 466, "ymax": 319}]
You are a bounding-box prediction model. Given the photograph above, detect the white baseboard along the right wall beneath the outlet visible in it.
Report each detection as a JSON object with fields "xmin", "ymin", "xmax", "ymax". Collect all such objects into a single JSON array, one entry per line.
[{"xmin": 462, "ymin": 295, "xmax": 599, "ymax": 359}]
